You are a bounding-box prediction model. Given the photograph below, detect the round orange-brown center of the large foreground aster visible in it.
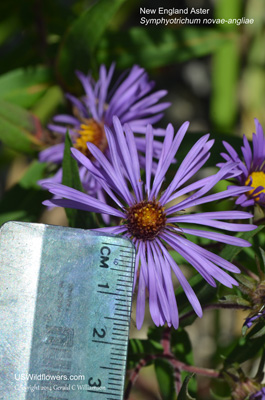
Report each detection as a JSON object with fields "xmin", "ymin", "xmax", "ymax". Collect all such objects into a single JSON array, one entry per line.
[{"xmin": 127, "ymin": 200, "xmax": 166, "ymax": 241}]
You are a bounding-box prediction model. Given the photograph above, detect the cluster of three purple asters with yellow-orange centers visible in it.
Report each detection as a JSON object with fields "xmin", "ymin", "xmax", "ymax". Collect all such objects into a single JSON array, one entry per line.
[{"xmin": 40, "ymin": 66, "xmax": 265, "ymax": 329}]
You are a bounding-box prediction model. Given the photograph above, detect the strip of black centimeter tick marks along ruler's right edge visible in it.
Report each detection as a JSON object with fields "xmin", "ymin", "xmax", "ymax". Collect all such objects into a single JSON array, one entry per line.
[{"xmin": 88, "ymin": 242, "xmax": 133, "ymax": 400}]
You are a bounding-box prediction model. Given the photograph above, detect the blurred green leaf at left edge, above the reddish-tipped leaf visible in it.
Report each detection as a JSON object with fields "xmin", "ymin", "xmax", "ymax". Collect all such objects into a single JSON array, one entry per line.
[{"xmin": 0, "ymin": 67, "xmax": 51, "ymax": 108}]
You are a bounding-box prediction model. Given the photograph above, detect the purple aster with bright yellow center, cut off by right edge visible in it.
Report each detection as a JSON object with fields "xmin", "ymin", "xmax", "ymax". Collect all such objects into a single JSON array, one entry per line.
[{"xmin": 218, "ymin": 119, "xmax": 265, "ymax": 207}]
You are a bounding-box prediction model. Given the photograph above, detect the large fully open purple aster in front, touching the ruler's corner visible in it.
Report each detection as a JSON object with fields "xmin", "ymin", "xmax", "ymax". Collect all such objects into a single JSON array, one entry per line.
[{"xmin": 44, "ymin": 117, "xmax": 255, "ymax": 328}]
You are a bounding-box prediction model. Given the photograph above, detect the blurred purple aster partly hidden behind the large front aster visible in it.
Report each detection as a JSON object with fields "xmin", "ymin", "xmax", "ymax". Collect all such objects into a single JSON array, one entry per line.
[{"xmin": 40, "ymin": 64, "xmax": 170, "ymax": 164}]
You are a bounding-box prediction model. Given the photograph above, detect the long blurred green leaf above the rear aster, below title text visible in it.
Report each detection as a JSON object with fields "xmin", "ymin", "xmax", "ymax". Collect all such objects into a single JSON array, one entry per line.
[{"xmin": 97, "ymin": 26, "xmax": 232, "ymax": 68}]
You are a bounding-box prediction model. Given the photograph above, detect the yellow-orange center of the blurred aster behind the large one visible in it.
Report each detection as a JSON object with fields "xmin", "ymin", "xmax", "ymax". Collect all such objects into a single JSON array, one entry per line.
[{"xmin": 74, "ymin": 118, "xmax": 107, "ymax": 158}]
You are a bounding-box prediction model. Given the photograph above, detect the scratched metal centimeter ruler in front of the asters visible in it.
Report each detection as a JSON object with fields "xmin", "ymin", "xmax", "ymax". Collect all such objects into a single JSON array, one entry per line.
[{"xmin": 0, "ymin": 222, "xmax": 135, "ymax": 400}]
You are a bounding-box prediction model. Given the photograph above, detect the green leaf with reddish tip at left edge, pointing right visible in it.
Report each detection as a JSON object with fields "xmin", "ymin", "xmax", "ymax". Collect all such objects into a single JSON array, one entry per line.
[{"xmin": 0, "ymin": 100, "xmax": 41, "ymax": 153}]
